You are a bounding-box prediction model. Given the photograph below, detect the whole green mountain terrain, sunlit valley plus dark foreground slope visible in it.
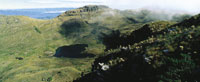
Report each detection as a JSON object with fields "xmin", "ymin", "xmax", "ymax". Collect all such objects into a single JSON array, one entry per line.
[{"xmin": 0, "ymin": 5, "xmax": 200, "ymax": 82}]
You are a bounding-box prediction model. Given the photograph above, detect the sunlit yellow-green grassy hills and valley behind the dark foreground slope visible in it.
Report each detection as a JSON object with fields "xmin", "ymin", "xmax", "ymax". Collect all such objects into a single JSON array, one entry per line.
[{"xmin": 0, "ymin": 5, "xmax": 194, "ymax": 82}]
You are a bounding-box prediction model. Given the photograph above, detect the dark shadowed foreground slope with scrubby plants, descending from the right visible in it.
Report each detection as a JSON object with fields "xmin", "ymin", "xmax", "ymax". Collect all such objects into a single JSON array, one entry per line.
[{"xmin": 74, "ymin": 11, "xmax": 200, "ymax": 82}]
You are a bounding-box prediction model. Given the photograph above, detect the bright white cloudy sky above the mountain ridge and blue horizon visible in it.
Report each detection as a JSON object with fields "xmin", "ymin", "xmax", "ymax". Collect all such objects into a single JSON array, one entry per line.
[{"xmin": 0, "ymin": 0, "xmax": 200, "ymax": 13}]
